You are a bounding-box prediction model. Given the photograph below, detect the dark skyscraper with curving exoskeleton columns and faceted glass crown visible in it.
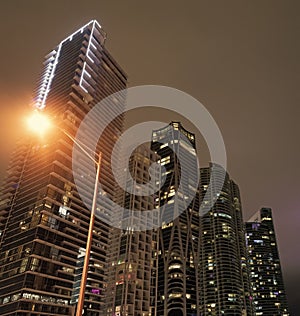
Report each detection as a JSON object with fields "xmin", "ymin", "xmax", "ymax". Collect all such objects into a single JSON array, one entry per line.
[{"xmin": 151, "ymin": 122, "xmax": 200, "ymax": 316}]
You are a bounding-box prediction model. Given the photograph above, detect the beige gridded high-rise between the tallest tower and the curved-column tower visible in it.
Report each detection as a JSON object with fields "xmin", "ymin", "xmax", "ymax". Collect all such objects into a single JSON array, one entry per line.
[{"xmin": 105, "ymin": 145, "xmax": 160, "ymax": 316}]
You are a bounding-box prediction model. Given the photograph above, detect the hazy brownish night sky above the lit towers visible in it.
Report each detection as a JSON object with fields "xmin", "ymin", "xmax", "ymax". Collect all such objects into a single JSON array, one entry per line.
[{"xmin": 0, "ymin": 0, "xmax": 300, "ymax": 316}]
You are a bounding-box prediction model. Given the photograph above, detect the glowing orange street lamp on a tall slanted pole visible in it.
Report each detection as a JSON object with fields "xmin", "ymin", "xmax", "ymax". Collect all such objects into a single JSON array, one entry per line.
[{"xmin": 27, "ymin": 111, "xmax": 102, "ymax": 316}]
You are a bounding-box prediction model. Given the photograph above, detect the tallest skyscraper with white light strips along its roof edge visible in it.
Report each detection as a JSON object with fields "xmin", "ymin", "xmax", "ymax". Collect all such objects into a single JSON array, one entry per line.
[{"xmin": 0, "ymin": 20, "xmax": 127, "ymax": 316}]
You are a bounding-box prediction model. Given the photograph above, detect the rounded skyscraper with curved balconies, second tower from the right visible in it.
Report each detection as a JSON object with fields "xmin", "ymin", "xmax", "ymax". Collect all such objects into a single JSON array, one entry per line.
[{"xmin": 199, "ymin": 164, "xmax": 253, "ymax": 316}]
